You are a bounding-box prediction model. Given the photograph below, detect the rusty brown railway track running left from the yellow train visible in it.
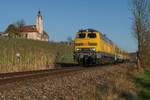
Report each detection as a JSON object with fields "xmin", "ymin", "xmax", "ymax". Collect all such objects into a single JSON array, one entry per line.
[{"xmin": 0, "ymin": 67, "xmax": 85, "ymax": 85}]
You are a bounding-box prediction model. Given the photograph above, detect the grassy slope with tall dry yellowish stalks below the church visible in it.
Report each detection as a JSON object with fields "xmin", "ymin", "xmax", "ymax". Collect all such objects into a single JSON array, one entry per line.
[{"xmin": 0, "ymin": 38, "xmax": 73, "ymax": 72}]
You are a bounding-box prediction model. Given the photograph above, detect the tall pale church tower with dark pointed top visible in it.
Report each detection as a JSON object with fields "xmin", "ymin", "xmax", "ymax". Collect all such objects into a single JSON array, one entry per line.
[{"xmin": 36, "ymin": 11, "xmax": 43, "ymax": 34}]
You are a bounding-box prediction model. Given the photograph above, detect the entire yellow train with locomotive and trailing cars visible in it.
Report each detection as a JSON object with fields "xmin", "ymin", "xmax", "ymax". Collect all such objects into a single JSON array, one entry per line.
[{"xmin": 74, "ymin": 29, "xmax": 129, "ymax": 65}]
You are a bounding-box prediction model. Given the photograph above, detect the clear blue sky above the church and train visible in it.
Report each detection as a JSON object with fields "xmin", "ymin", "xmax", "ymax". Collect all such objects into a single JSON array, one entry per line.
[{"xmin": 0, "ymin": 0, "xmax": 137, "ymax": 52}]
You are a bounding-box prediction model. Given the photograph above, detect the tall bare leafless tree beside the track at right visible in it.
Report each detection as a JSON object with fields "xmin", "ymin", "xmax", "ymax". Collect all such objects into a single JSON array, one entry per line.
[{"xmin": 132, "ymin": 0, "xmax": 150, "ymax": 69}]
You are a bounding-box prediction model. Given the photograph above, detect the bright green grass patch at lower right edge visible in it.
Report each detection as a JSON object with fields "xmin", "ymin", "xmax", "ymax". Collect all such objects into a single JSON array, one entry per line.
[{"xmin": 135, "ymin": 70, "xmax": 150, "ymax": 100}]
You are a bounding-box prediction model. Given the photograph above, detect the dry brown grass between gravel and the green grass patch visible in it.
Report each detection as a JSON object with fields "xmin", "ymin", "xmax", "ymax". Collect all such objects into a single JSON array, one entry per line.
[{"xmin": 95, "ymin": 64, "xmax": 137, "ymax": 100}]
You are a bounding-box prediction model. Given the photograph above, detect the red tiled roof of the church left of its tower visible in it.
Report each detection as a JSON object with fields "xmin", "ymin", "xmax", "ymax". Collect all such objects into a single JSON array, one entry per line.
[{"xmin": 20, "ymin": 25, "xmax": 38, "ymax": 32}]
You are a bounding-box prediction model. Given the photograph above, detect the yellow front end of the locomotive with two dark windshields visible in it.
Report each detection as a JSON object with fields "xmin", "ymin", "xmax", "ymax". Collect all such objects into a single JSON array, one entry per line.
[{"xmin": 74, "ymin": 29, "xmax": 98, "ymax": 65}]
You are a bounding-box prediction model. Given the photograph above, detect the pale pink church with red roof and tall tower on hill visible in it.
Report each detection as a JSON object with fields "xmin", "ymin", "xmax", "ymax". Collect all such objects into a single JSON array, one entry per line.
[{"xmin": 20, "ymin": 11, "xmax": 49, "ymax": 41}]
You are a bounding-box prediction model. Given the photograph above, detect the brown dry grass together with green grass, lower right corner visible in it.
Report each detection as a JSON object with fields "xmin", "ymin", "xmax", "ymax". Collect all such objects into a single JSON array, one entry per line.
[{"xmin": 96, "ymin": 66, "xmax": 150, "ymax": 100}]
